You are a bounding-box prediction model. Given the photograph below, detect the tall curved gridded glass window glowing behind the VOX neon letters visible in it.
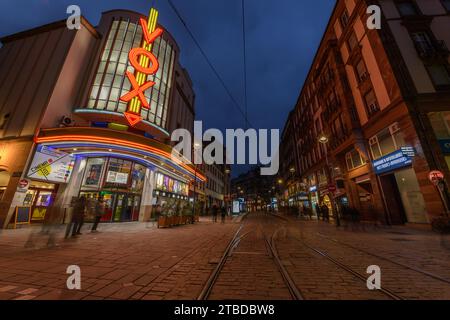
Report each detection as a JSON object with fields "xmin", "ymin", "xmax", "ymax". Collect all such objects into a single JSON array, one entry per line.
[{"xmin": 87, "ymin": 20, "xmax": 175, "ymax": 128}]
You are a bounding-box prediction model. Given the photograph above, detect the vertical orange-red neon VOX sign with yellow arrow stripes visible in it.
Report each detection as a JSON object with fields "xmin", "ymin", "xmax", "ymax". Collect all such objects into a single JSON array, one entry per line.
[{"xmin": 120, "ymin": 8, "xmax": 163, "ymax": 126}]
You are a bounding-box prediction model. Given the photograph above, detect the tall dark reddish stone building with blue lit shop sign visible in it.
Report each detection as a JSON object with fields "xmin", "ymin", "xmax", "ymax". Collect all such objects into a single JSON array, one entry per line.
[{"xmin": 285, "ymin": 0, "xmax": 450, "ymax": 224}]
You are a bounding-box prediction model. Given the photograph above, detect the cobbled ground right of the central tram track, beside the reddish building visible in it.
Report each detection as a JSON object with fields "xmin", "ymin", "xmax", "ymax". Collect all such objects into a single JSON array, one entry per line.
[{"xmin": 277, "ymin": 220, "xmax": 450, "ymax": 300}]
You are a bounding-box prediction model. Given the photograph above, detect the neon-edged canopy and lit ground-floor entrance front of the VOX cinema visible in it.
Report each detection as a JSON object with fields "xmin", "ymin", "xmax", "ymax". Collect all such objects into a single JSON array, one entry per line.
[{"xmin": 1, "ymin": 127, "xmax": 206, "ymax": 223}]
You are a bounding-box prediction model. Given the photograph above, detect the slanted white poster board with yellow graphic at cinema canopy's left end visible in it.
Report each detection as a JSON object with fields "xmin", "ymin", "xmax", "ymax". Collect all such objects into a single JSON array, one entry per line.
[{"xmin": 27, "ymin": 145, "xmax": 75, "ymax": 183}]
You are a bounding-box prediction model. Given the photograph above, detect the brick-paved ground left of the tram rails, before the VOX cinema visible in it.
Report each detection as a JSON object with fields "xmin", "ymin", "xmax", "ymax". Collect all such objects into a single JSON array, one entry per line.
[{"xmin": 0, "ymin": 221, "xmax": 238, "ymax": 300}]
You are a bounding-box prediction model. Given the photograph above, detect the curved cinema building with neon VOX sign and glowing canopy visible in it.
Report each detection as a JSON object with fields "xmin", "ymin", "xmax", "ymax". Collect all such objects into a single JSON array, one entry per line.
[{"xmin": 0, "ymin": 10, "xmax": 205, "ymax": 227}]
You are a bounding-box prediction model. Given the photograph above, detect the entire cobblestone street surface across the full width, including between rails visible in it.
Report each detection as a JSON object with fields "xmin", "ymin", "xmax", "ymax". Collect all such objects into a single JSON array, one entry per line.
[{"xmin": 0, "ymin": 213, "xmax": 450, "ymax": 300}]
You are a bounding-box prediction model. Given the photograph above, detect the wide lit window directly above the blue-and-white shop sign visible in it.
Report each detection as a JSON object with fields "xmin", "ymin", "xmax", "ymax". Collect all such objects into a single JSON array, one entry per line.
[{"xmin": 369, "ymin": 123, "xmax": 405, "ymax": 160}]
